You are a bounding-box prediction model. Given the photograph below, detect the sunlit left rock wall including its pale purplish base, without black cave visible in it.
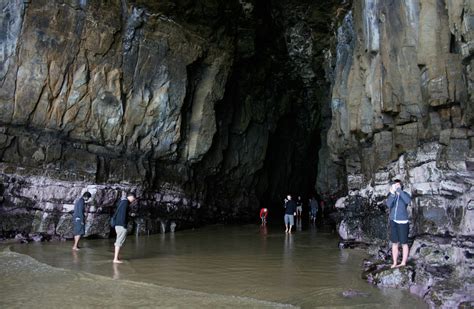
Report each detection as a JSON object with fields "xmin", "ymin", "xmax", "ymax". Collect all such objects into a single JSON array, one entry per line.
[{"xmin": 0, "ymin": 0, "xmax": 233, "ymax": 236}]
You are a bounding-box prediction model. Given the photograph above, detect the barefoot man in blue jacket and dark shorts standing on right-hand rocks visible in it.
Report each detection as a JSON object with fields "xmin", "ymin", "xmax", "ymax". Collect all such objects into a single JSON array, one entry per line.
[{"xmin": 387, "ymin": 180, "xmax": 411, "ymax": 268}]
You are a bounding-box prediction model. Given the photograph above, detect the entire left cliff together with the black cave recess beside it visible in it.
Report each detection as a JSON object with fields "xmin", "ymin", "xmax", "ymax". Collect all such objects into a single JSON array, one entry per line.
[{"xmin": 0, "ymin": 0, "xmax": 339, "ymax": 237}]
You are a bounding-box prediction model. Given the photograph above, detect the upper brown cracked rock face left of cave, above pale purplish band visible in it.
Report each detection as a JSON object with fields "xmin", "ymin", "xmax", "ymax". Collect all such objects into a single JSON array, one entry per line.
[{"xmin": 0, "ymin": 1, "xmax": 232, "ymax": 181}]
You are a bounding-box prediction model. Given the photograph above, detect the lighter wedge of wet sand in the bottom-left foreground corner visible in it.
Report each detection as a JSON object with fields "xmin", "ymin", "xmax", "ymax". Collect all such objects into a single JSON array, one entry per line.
[{"xmin": 0, "ymin": 250, "xmax": 290, "ymax": 308}]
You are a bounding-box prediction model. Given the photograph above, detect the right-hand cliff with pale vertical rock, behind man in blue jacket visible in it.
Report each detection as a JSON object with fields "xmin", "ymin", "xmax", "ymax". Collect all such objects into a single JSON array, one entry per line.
[{"xmin": 318, "ymin": 0, "xmax": 474, "ymax": 307}]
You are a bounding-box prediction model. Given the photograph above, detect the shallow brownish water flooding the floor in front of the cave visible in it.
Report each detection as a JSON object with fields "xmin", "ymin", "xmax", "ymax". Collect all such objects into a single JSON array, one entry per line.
[{"xmin": 0, "ymin": 221, "xmax": 427, "ymax": 308}]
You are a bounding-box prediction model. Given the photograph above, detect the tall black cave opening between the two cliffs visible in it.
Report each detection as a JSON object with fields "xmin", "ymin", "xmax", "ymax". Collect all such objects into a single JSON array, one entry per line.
[{"xmin": 189, "ymin": 1, "xmax": 337, "ymax": 222}]
